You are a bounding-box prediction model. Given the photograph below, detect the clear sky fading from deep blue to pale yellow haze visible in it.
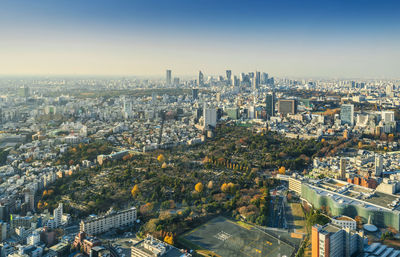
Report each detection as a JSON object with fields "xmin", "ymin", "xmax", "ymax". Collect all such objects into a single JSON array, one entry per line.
[{"xmin": 0, "ymin": 0, "xmax": 400, "ymax": 78}]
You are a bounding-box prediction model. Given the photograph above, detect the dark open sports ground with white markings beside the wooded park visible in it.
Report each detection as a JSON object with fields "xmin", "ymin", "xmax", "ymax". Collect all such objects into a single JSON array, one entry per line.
[{"xmin": 182, "ymin": 217, "xmax": 294, "ymax": 257}]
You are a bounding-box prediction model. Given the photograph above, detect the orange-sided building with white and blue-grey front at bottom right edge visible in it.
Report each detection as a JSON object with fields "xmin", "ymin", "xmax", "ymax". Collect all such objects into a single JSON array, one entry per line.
[{"xmin": 311, "ymin": 223, "xmax": 364, "ymax": 257}]
